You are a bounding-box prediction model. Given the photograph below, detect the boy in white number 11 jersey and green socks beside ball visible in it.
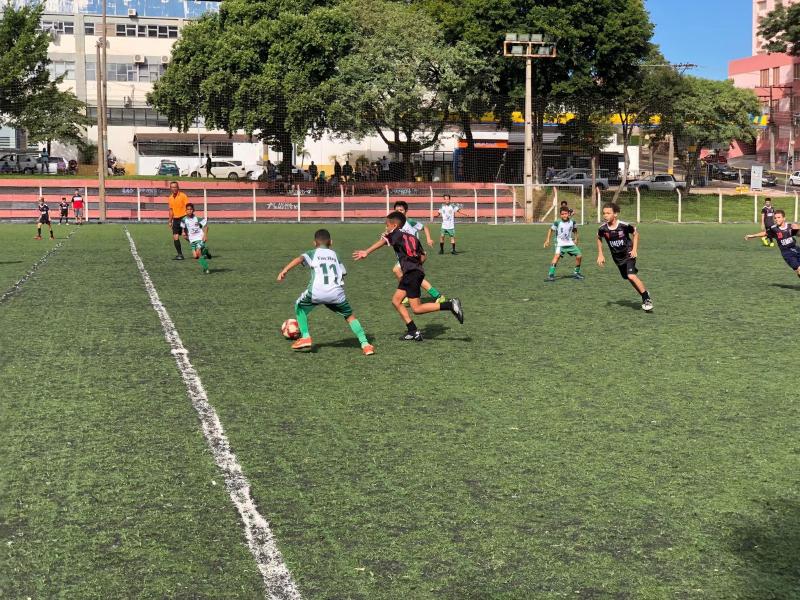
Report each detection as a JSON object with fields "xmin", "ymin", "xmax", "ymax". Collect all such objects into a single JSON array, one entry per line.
[{"xmin": 278, "ymin": 229, "xmax": 375, "ymax": 356}]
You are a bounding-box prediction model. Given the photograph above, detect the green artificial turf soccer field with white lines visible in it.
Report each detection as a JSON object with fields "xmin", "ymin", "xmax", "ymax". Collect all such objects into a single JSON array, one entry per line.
[{"xmin": 0, "ymin": 223, "xmax": 800, "ymax": 600}]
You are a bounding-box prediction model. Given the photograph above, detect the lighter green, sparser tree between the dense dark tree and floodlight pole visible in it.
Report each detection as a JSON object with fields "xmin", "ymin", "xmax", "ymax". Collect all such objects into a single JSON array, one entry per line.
[{"xmin": 325, "ymin": 0, "xmax": 484, "ymax": 178}]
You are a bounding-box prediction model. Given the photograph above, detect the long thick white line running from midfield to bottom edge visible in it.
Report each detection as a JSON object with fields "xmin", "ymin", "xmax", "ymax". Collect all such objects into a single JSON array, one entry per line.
[{"xmin": 125, "ymin": 227, "xmax": 301, "ymax": 600}]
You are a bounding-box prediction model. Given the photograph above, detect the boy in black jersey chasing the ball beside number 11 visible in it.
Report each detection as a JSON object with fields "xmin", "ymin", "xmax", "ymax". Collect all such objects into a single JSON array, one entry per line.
[{"xmin": 353, "ymin": 211, "xmax": 464, "ymax": 342}]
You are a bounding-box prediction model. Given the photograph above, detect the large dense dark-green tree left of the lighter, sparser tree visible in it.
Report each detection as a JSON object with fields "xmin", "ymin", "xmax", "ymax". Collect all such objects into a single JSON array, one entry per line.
[{"xmin": 148, "ymin": 0, "xmax": 351, "ymax": 174}]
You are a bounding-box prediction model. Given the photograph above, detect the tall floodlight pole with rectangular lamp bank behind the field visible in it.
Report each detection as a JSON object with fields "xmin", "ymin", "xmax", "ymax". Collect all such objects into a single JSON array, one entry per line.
[{"xmin": 503, "ymin": 33, "xmax": 558, "ymax": 221}]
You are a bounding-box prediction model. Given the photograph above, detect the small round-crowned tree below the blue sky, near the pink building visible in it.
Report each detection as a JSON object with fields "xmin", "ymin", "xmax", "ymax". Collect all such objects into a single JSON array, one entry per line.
[{"xmin": 659, "ymin": 75, "xmax": 760, "ymax": 191}]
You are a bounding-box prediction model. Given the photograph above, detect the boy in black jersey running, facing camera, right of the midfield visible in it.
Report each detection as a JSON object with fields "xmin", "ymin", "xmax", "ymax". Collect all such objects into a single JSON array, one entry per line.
[{"xmin": 597, "ymin": 202, "xmax": 653, "ymax": 312}]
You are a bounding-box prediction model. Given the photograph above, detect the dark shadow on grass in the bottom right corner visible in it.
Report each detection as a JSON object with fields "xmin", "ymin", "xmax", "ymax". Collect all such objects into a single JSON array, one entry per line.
[{"xmin": 731, "ymin": 499, "xmax": 800, "ymax": 598}]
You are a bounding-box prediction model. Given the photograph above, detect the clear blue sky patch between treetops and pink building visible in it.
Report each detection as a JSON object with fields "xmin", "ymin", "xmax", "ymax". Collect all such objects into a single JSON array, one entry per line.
[{"xmin": 645, "ymin": 0, "xmax": 753, "ymax": 79}]
